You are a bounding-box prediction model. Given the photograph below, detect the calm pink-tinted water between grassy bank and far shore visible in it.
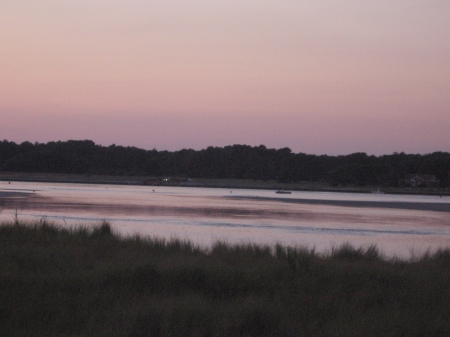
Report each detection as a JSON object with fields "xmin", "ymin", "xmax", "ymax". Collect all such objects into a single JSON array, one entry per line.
[{"xmin": 0, "ymin": 182, "xmax": 450, "ymax": 257}]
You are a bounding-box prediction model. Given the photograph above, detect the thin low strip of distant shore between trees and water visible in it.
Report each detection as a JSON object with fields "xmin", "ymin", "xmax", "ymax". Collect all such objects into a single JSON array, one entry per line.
[{"xmin": 0, "ymin": 172, "xmax": 450, "ymax": 196}]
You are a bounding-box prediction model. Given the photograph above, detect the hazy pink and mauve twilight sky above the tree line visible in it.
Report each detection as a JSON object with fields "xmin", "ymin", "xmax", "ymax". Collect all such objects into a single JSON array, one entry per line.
[{"xmin": 0, "ymin": 0, "xmax": 450, "ymax": 155}]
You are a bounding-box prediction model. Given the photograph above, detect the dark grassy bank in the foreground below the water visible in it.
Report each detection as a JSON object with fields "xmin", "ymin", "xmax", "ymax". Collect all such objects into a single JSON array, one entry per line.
[{"xmin": 0, "ymin": 220, "xmax": 450, "ymax": 336}]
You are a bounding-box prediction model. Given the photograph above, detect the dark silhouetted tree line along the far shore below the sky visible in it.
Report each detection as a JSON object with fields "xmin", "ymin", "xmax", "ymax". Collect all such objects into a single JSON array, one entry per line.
[{"xmin": 0, "ymin": 140, "xmax": 450, "ymax": 187}]
